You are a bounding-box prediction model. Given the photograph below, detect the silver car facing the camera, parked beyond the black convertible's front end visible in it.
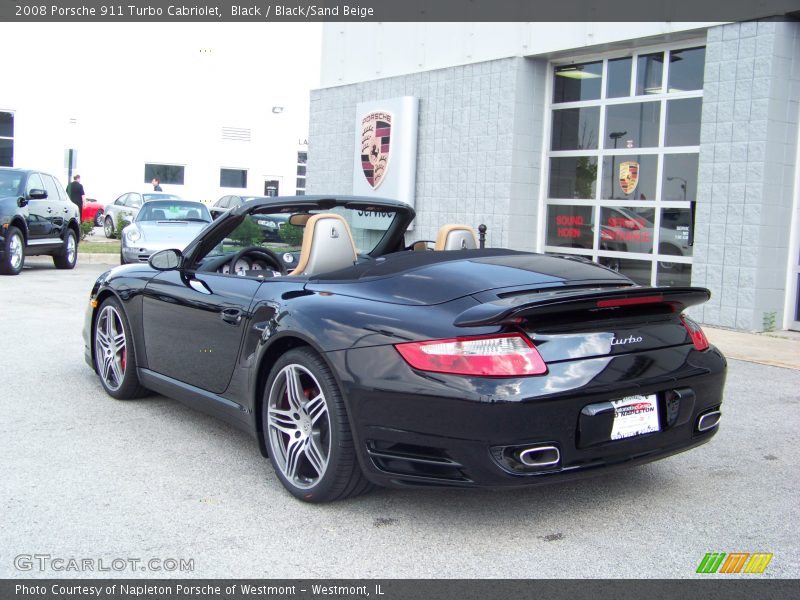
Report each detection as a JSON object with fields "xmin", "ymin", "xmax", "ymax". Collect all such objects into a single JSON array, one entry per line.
[{"xmin": 119, "ymin": 200, "xmax": 211, "ymax": 265}]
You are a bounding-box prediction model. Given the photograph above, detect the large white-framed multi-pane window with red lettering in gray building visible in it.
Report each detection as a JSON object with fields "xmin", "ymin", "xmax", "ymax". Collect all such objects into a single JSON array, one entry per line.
[{"xmin": 543, "ymin": 47, "xmax": 705, "ymax": 285}]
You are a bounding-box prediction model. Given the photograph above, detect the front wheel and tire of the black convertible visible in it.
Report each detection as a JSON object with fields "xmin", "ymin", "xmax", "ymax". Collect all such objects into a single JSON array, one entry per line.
[{"xmin": 92, "ymin": 297, "xmax": 148, "ymax": 400}]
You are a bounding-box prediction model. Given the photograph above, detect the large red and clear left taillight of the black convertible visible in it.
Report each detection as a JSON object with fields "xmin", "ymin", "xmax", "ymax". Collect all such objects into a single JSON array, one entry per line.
[{"xmin": 395, "ymin": 333, "xmax": 547, "ymax": 377}]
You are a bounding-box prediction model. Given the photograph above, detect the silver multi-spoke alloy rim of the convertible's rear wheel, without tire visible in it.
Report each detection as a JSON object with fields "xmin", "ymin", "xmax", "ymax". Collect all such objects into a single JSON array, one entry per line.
[{"xmin": 267, "ymin": 364, "xmax": 331, "ymax": 489}]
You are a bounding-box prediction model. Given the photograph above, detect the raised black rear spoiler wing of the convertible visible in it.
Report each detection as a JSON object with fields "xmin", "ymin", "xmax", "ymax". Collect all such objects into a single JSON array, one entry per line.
[{"xmin": 453, "ymin": 287, "xmax": 711, "ymax": 327}]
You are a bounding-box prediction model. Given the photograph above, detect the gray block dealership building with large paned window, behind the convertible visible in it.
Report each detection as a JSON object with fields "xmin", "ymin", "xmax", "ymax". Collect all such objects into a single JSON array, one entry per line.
[{"xmin": 306, "ymin": 19, "xmax": 800, "ymax": 330}]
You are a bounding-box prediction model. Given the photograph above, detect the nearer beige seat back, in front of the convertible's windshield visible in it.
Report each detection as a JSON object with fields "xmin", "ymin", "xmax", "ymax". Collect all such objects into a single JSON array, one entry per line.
[{"xmin": 290, "ymin": 213, "xmax": 358, "ymax": 275}]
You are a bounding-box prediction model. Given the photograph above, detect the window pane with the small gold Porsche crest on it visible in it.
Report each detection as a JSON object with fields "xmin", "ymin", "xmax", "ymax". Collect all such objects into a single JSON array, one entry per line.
[{"xmin": 601, "ymin": 154, "xmax": 658, "ymax": 200}]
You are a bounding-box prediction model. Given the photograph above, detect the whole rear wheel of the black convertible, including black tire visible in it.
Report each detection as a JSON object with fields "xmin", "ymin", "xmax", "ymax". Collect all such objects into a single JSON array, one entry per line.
[{"xmin": 261, "ymin": 348, "xmax": 372, "ymax": 502}]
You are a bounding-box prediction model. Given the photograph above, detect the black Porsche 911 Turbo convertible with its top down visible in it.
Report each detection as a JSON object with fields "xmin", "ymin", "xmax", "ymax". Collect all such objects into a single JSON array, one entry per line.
[{"xmin": 84, "ymin": 196, "xmax": 726, "ymax": 502}]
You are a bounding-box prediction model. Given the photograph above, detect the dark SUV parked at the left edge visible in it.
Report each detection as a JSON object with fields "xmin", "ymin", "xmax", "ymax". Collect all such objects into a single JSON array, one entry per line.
[{"xmin": 0, "ymin": 168, "xmax": 81, "ymax": 275}]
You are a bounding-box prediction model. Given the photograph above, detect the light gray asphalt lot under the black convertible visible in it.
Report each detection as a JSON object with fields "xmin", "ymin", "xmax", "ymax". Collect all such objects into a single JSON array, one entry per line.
[{"xmin": 0, "ymin": 258, "xmax": 800, "ymax": 578}]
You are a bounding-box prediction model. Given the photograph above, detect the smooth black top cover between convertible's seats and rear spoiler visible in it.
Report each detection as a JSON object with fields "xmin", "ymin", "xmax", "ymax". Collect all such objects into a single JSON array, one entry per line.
[{"xmin": 306, "ymin": 250, "xmax": 631, "ymax": 305}]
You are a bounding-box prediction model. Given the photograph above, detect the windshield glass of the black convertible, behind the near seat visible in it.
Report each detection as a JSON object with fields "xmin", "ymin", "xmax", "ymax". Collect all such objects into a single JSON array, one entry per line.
[{"xmin": 203, "ymin": 207, "xmax": 396, "ymax": 256}]
